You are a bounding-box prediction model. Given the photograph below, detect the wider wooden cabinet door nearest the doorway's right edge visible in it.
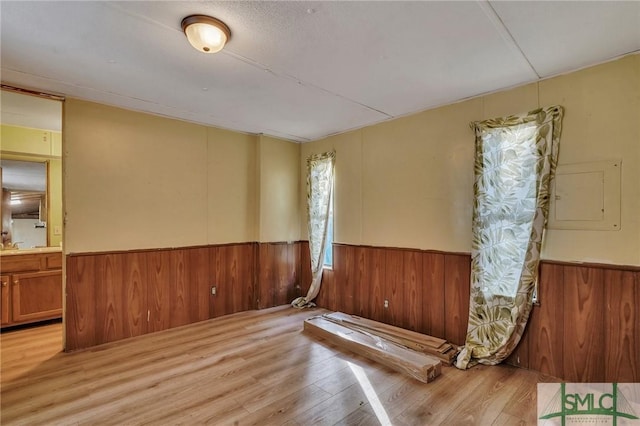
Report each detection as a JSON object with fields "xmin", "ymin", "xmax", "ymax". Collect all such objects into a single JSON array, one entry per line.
[{"xmin": 12, "ymin": 270, "xmax": 62, "ymax": 322}]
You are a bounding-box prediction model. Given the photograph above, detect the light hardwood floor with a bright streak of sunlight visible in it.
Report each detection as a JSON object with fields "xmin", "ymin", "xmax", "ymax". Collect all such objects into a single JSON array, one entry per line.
[{"xmin": 1, "ymin": 307, "xmax": 555, "ymax": 425}]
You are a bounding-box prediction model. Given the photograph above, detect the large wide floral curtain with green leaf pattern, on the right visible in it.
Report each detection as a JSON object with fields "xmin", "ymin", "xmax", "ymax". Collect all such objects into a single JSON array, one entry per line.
[{"xmin": 456, "ymin": 106, "xmax": 563, "ymax": 369}]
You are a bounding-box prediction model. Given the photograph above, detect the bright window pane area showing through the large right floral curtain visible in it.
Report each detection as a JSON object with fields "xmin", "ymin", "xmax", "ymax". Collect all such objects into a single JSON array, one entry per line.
[{"xmin": 473, "ymin": 122, "xmax": 538, "ymax": 297}]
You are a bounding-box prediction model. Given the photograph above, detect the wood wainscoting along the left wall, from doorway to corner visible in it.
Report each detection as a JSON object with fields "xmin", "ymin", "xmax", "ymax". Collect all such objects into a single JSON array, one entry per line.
[{"xmin": 65, "ymin": 242, "xmax": 308, "ymax": 351}]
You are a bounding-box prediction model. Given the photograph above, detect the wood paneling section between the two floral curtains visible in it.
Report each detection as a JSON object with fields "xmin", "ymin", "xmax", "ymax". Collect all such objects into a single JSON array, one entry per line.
[{"xmin": 316, "ymin": 244, "xmax": 471, "ymax": 344}]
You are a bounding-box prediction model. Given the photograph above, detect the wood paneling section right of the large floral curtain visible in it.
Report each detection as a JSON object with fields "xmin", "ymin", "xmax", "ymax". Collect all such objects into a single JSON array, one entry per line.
[{"xmin": 507, "ymin": 261, "xmax": 640, "ymax": 383}]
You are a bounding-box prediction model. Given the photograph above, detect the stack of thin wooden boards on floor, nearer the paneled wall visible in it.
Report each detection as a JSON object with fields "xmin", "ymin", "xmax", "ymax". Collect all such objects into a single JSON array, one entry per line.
[{"xmin": 323, "ymin": 312, "xmax": 458, "ymax": 365}]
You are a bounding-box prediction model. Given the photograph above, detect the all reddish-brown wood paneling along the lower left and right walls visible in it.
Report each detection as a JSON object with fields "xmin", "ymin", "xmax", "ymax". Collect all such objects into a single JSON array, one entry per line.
[{"xmin": 65, "ymin": 241, "xmax": 640, "ymax": 382}]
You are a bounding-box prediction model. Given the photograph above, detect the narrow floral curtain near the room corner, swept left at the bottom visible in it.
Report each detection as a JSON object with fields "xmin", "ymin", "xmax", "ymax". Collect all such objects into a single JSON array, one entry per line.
[{"xmin": 291, "ymin": 151, "xmax": 336, "ymax": 308}]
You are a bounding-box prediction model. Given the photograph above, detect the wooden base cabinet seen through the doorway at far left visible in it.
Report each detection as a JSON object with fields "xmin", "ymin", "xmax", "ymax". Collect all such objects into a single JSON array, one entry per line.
[{"xmin": 0, "ymin": 253, "xmax": 62, "ymax": 327}]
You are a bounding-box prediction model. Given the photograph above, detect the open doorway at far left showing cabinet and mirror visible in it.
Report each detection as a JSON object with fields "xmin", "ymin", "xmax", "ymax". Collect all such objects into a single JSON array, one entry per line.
[{"xmin": 0, "ymin": 85, "xmax": 65, "ymax": 349}]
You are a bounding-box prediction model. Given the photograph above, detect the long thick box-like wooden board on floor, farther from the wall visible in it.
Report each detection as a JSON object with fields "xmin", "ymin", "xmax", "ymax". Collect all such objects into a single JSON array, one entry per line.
[{"xmin": 304, "ymin": 317, "xmax": 442, "ymax": 383}]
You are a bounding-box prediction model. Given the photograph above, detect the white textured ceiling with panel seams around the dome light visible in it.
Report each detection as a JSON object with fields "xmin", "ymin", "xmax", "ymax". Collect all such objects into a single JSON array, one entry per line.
[{"xmin": 0, "ymin": 1, "xmax": 640, "ymax": 141}]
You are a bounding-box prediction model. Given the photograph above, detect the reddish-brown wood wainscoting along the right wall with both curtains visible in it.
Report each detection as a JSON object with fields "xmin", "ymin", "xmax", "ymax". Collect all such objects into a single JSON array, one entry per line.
[{"xmin": 316, "ymin": 243, "xmax": 640, "ymax": 383}]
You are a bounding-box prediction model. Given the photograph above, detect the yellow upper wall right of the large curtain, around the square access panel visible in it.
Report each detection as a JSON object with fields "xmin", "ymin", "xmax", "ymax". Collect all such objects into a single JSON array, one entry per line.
[{"xmin": 540, "ymin": 55, "xmax": 640, "ymax": 265}]
